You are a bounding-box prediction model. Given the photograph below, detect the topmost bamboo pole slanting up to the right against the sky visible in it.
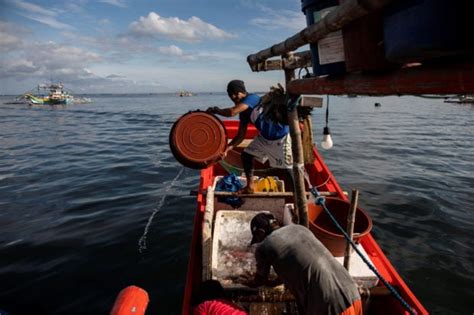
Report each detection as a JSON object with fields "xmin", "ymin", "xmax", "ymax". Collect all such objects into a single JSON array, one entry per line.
[{"xmin": 247, "ymin": 0, "xmax": 392, "ymax": 71}]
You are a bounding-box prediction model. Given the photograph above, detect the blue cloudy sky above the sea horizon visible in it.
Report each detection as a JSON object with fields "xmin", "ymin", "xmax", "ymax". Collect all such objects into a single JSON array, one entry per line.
[{"xmin": 0, "ymin": 0, "xmax": 307, "ymax": 95}]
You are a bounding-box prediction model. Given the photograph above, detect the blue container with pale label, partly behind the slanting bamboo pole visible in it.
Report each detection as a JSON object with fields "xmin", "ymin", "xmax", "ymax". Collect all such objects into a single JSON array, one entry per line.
[{"xmin": 301, "ymin": 0, "xmax": 346, "ymax": 76}]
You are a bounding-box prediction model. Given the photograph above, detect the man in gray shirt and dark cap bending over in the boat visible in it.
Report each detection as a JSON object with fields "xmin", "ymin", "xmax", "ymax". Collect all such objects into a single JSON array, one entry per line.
[{"xmin": 248, "ymin": 213, "xmax": 362, "ymax": 314}]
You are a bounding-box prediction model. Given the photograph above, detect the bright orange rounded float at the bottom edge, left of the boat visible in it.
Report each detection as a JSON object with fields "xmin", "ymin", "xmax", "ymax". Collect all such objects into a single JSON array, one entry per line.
[{"xmin": 110, "ymin": 285, "xmax": 149, "ymax": 315}]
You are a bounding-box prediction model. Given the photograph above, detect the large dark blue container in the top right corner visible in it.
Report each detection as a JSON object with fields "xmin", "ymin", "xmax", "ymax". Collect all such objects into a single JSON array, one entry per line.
[{"xmin": 384, "ymin": 0, "xmax": 474, "ymax": 63}]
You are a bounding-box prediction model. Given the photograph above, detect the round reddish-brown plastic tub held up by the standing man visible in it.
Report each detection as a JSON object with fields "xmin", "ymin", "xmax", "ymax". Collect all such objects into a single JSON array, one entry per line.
[{"xmin": 170, "ymin": 111, "xmax": 227, "ymax": 169}]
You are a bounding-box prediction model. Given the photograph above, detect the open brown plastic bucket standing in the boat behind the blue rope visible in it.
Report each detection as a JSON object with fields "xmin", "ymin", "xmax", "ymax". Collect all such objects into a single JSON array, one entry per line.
[{"xmin": 308, "ymin": 198, "xmax": 372, "ymax": 257}]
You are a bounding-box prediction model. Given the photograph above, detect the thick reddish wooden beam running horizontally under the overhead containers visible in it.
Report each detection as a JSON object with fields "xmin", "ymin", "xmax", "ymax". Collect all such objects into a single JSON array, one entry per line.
[{"xmin": 287, "ymin": 61, "xmax": 474, "ymax": 95}]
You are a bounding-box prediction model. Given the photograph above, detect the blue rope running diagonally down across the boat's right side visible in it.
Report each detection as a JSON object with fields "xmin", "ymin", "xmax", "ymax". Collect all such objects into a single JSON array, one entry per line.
[{"xmin": 311, "ymin": 187, "xmax": 416, "ymax": 315}]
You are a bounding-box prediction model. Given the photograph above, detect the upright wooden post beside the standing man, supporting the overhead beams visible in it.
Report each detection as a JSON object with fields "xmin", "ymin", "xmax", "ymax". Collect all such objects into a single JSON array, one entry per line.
[{"xmin": 284, "ymin": 54, "xmax": 308, "ymax": 227}]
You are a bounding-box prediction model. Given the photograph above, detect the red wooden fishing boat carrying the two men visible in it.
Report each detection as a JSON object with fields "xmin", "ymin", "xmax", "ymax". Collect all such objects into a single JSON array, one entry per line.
[{"xmin": 176, "ymin": 120, "xmax": 427, "ymax": 314}]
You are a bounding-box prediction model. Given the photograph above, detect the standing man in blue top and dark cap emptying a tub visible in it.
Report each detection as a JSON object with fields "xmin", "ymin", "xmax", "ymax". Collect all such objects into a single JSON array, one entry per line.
[{"xmin": 207, "ymin": 80, "xmax": 293, "ymax": 193}]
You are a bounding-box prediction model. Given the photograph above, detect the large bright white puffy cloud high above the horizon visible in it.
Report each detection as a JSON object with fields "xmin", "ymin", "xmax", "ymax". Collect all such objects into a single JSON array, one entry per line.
[{"xmin": 129, "ymin": 12, "xmax": 236, "ymax": 42}]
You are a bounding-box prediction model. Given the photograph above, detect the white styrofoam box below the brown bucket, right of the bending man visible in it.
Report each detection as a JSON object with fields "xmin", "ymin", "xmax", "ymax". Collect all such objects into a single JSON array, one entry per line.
[{"xmin": 334, "ymin": 244, "xmax": 379, "ymax": 289}]
